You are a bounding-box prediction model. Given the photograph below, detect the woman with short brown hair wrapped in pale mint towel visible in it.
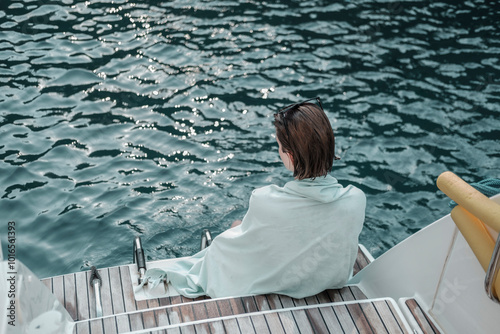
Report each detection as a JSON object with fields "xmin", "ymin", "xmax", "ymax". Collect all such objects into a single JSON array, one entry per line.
[{"xmin": 166, "ymin": 98, "xmax": 366, "ymax": 298}]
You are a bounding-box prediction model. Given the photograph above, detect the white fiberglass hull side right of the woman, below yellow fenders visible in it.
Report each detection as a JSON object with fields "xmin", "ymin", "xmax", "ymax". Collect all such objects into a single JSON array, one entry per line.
[{"xmin": 351, "ymin": 195, "xmax": 500, "ymax": 333}]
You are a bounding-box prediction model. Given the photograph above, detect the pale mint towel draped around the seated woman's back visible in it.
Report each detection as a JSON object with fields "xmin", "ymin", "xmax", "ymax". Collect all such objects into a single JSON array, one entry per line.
[{"xmin": 166, "ymin": 176, "xmax": 365, "ymax": 298}]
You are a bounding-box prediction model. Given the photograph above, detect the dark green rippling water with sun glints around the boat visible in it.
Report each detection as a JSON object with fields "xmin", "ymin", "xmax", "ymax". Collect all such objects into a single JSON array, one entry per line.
[{"xmin": 0, "ymin": 0, "xmax": 500, "ymax": 277}]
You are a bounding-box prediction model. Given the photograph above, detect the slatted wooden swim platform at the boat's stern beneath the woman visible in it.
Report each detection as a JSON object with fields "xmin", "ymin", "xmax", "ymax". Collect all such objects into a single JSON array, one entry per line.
[{"xmin": 41, "ymin": 248, "xmax": 412, "ymax": 334}]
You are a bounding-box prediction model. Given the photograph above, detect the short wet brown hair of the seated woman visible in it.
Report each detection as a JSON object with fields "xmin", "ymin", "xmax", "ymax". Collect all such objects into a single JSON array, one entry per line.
[{"xmin": 274, "ymin": 103, "xmax": 338, "ymax": 180}]
